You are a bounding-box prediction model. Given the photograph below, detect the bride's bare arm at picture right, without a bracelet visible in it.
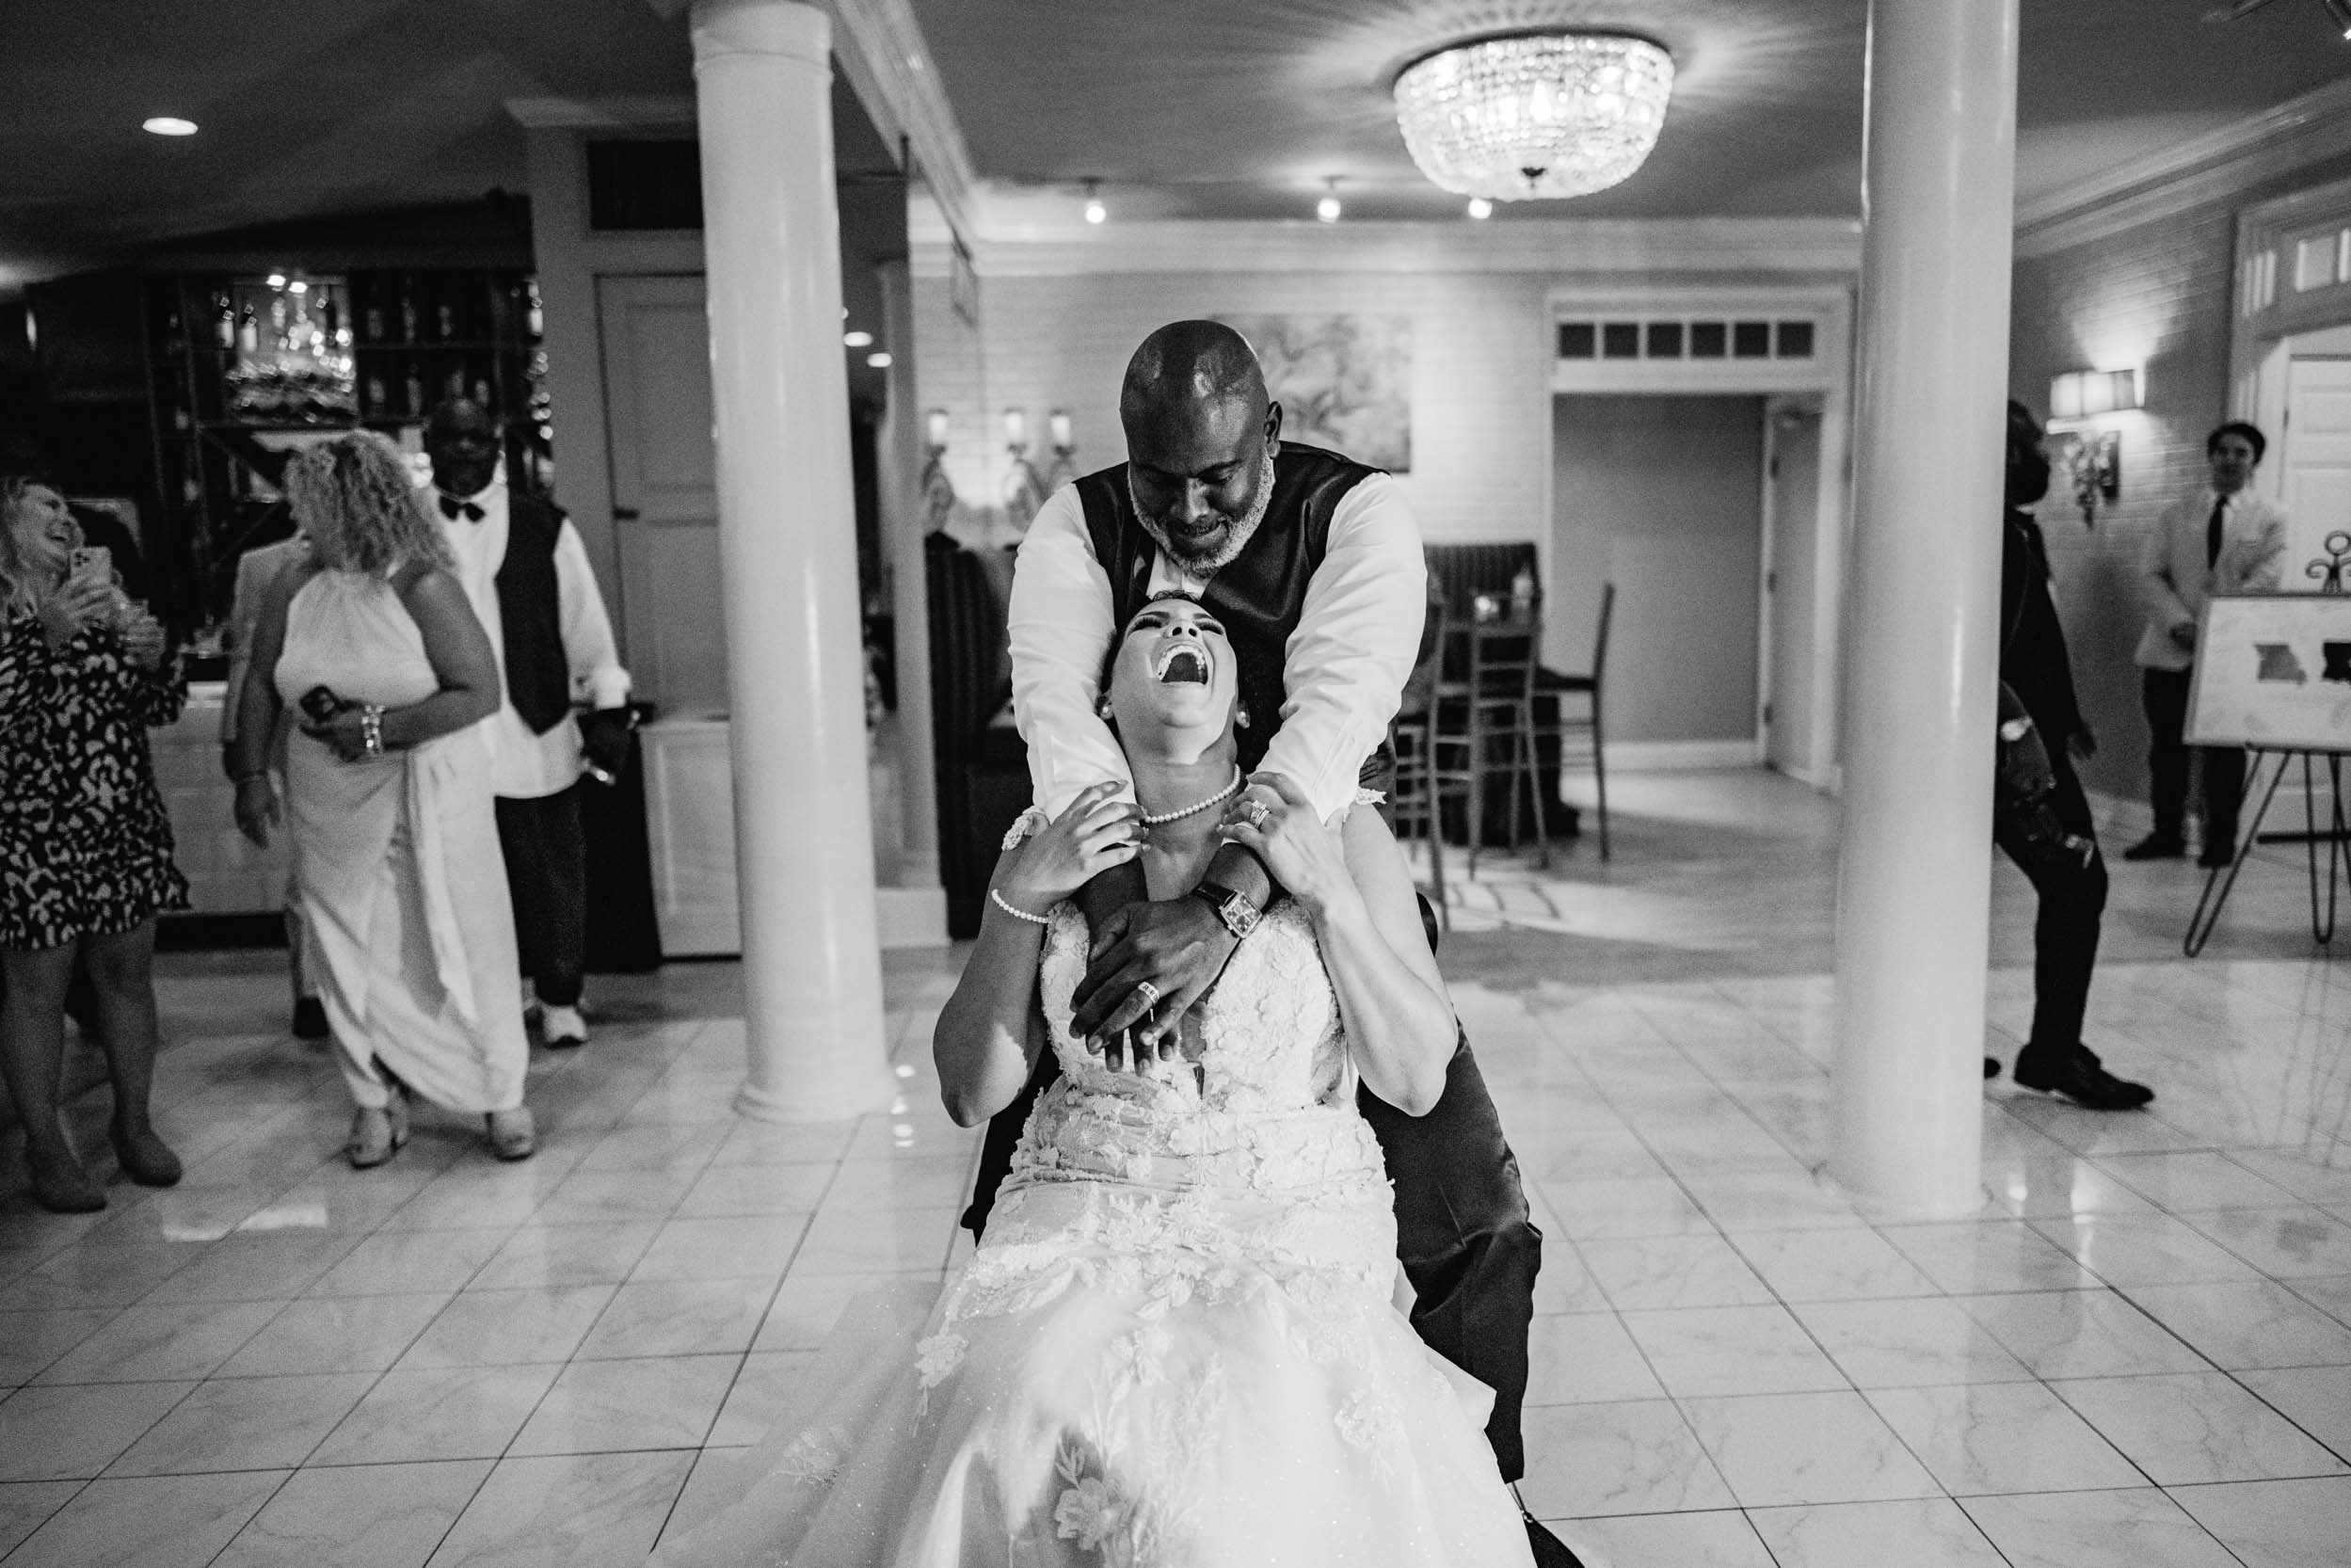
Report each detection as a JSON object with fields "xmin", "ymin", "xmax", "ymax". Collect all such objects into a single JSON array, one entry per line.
[{"xmin": 1224, "ymin": 774, "xmax": 1458, "ymax": 1116}]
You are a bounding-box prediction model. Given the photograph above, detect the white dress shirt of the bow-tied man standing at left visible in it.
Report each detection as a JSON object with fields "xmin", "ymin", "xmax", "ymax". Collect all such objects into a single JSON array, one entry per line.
[{"xmin": 425, "ymin": 485, "xmax": 628, "ymax": 799}]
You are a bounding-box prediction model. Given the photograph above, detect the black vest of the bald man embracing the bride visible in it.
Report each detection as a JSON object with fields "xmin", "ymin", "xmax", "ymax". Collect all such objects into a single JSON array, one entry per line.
[{"xmin": 1077, "ymin": 442, "xmax": 1380, "ymax": 769}]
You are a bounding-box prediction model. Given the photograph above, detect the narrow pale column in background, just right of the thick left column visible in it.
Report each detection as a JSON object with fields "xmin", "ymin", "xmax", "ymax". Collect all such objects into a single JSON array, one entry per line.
[{"xmin": 874, "ymin": 259, "xmax": 938, "ymax": 887}]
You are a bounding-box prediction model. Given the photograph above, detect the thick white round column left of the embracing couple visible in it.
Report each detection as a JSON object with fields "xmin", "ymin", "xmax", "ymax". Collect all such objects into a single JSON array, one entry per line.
[{"xmin": 694, "ymin": 0, "xmax": 893, "ymax": 1121}]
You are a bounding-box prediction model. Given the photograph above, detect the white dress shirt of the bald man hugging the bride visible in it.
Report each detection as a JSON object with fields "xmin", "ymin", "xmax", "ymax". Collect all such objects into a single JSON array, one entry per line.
[{"xmin": 1006, "ymin": 475, "xmax": 1430, "ymax": 821}]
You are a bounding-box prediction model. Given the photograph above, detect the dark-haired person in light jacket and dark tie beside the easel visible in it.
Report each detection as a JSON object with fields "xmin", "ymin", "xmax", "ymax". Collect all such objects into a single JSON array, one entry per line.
[{"xmin": 2123, "ymin": 419, "xmax": 2285, "ymax": 865}]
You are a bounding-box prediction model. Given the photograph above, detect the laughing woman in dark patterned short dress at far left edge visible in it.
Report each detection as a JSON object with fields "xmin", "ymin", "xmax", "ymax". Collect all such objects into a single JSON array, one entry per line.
[{"xmin": 0, "ymin": 480, "xmax": 188, "ymax": 1213}]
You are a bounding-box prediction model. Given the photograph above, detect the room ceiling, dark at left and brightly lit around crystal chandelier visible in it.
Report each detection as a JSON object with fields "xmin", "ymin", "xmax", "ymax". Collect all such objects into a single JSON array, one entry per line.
[{"xmin": 0, "ymin": 0, "xmax": 2351, "ymax": 292}]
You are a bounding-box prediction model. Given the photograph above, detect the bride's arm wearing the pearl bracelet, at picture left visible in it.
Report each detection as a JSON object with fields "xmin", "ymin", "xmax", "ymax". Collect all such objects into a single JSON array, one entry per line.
[{"xmin": 931, "ymin": 783, "xmax": 1138, "ymax": 1126}]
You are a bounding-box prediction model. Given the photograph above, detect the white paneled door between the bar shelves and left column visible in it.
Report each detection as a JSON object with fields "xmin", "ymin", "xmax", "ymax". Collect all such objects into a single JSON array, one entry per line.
[{"xmin": 597, "ymin": 278, "xmax": 727, "ymax": 714}]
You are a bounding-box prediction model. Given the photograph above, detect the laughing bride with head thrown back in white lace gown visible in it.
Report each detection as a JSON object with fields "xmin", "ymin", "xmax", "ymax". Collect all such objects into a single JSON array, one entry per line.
[{"xmin": 658, "ymin": 597, "xmax": 1530, "ymax": 1568}]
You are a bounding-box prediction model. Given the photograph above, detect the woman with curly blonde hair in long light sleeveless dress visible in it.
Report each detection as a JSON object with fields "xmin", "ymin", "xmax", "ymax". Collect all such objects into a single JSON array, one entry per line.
[{"xmin": 231, "ymin": 430, "xmax": 538, "ymax": 1168}]
